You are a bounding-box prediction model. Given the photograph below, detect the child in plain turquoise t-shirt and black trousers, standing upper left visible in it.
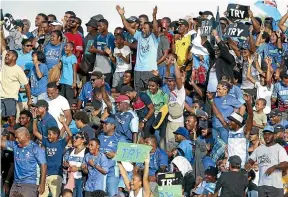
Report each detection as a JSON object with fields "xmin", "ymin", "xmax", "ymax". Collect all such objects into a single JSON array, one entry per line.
[{"xmin": 59, "ymin": 42, "xmax": 77, "ymax": 103}]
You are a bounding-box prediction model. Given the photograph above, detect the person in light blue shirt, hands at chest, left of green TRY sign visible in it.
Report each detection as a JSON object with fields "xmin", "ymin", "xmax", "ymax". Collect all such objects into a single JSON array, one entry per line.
[{"xmin": 81, "ymin": 138, "xmax": 109, "ymax": 196}]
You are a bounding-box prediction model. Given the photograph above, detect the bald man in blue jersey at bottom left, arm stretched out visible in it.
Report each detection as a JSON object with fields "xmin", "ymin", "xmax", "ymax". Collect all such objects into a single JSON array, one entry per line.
[{"xmin": 1, "ymin": 127, "xmax": 47, "ymax": 197}]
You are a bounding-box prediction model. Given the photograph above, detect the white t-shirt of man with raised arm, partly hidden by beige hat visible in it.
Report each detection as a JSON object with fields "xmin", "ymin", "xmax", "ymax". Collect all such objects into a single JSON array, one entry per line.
[{"xmin": 168, "ymin": 85, "xmax": 186, "ymax": 123}]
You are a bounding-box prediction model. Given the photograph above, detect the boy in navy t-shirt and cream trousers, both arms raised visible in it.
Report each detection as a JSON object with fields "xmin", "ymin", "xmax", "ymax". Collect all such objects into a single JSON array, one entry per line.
[{"xmin": 33, "ymin": 115, "xmax": 72, "ymax": 196}]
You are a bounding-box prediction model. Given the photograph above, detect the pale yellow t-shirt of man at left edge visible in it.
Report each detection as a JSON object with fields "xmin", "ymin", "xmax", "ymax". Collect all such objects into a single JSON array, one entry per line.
[{"xmin": 0, "ymin": 64, "xmax": 28, "ymax": 100}]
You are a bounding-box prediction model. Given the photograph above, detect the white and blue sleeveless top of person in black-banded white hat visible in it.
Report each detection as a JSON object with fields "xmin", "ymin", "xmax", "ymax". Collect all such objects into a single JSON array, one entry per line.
[{"xmin": 227, "ymin": 126, "xmax": 248, "ymax": 168}]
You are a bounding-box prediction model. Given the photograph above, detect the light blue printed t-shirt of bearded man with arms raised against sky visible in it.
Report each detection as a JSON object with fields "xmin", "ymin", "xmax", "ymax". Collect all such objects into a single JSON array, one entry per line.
[{"xmin": 134, "ymin": 31, "xmax": 160, "ymax": 71}]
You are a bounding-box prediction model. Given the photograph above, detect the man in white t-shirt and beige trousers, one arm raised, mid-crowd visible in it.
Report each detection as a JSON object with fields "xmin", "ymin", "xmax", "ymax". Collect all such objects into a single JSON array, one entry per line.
[{"xmin": 160, "ymin": 63, "xmax": 186, "ymax": 151}]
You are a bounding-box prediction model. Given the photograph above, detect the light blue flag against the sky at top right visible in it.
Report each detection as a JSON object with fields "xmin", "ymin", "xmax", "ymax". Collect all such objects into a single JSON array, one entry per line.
[{"xmin": 255, "ymin": 0, "xmax": 281, "ymax": 31}]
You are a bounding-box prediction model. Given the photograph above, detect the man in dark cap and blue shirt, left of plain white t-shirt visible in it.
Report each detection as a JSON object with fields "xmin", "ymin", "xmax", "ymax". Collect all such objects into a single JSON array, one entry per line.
[{"xmin": 33, "ymin": 100, "xmax": 58, "ymax": 137}]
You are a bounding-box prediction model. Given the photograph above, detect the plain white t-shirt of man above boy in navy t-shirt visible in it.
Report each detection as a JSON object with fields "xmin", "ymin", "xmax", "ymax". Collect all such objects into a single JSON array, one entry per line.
[{"xmin": 47, "ymin": 95, "xmax": 70, "ymax": 129}]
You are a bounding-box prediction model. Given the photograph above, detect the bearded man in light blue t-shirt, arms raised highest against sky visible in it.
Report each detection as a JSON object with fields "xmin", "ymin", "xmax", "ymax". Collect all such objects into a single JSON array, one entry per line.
[{"xmin": 116, "ymin": 5, "xmax": 159, "ymax": 91}]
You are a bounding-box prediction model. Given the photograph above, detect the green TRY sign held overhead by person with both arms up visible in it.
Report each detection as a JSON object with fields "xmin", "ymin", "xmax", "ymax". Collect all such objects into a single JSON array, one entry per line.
[{"xmin": 114, "ymin": 142, "xmax": 152, "ymax": 163}]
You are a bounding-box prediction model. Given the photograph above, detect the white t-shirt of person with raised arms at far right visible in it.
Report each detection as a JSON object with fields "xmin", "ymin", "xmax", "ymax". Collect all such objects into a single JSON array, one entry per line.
[{"xmin": 255, "ymin": 82, "xmax": 274, "ymax": 114}]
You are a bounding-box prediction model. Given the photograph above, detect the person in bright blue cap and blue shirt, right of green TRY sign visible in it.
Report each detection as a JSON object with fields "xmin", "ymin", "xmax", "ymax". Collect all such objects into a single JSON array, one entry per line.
[{"xmin": 168, "ymin": 127, "xmax": 194, "ymax": 163}]
